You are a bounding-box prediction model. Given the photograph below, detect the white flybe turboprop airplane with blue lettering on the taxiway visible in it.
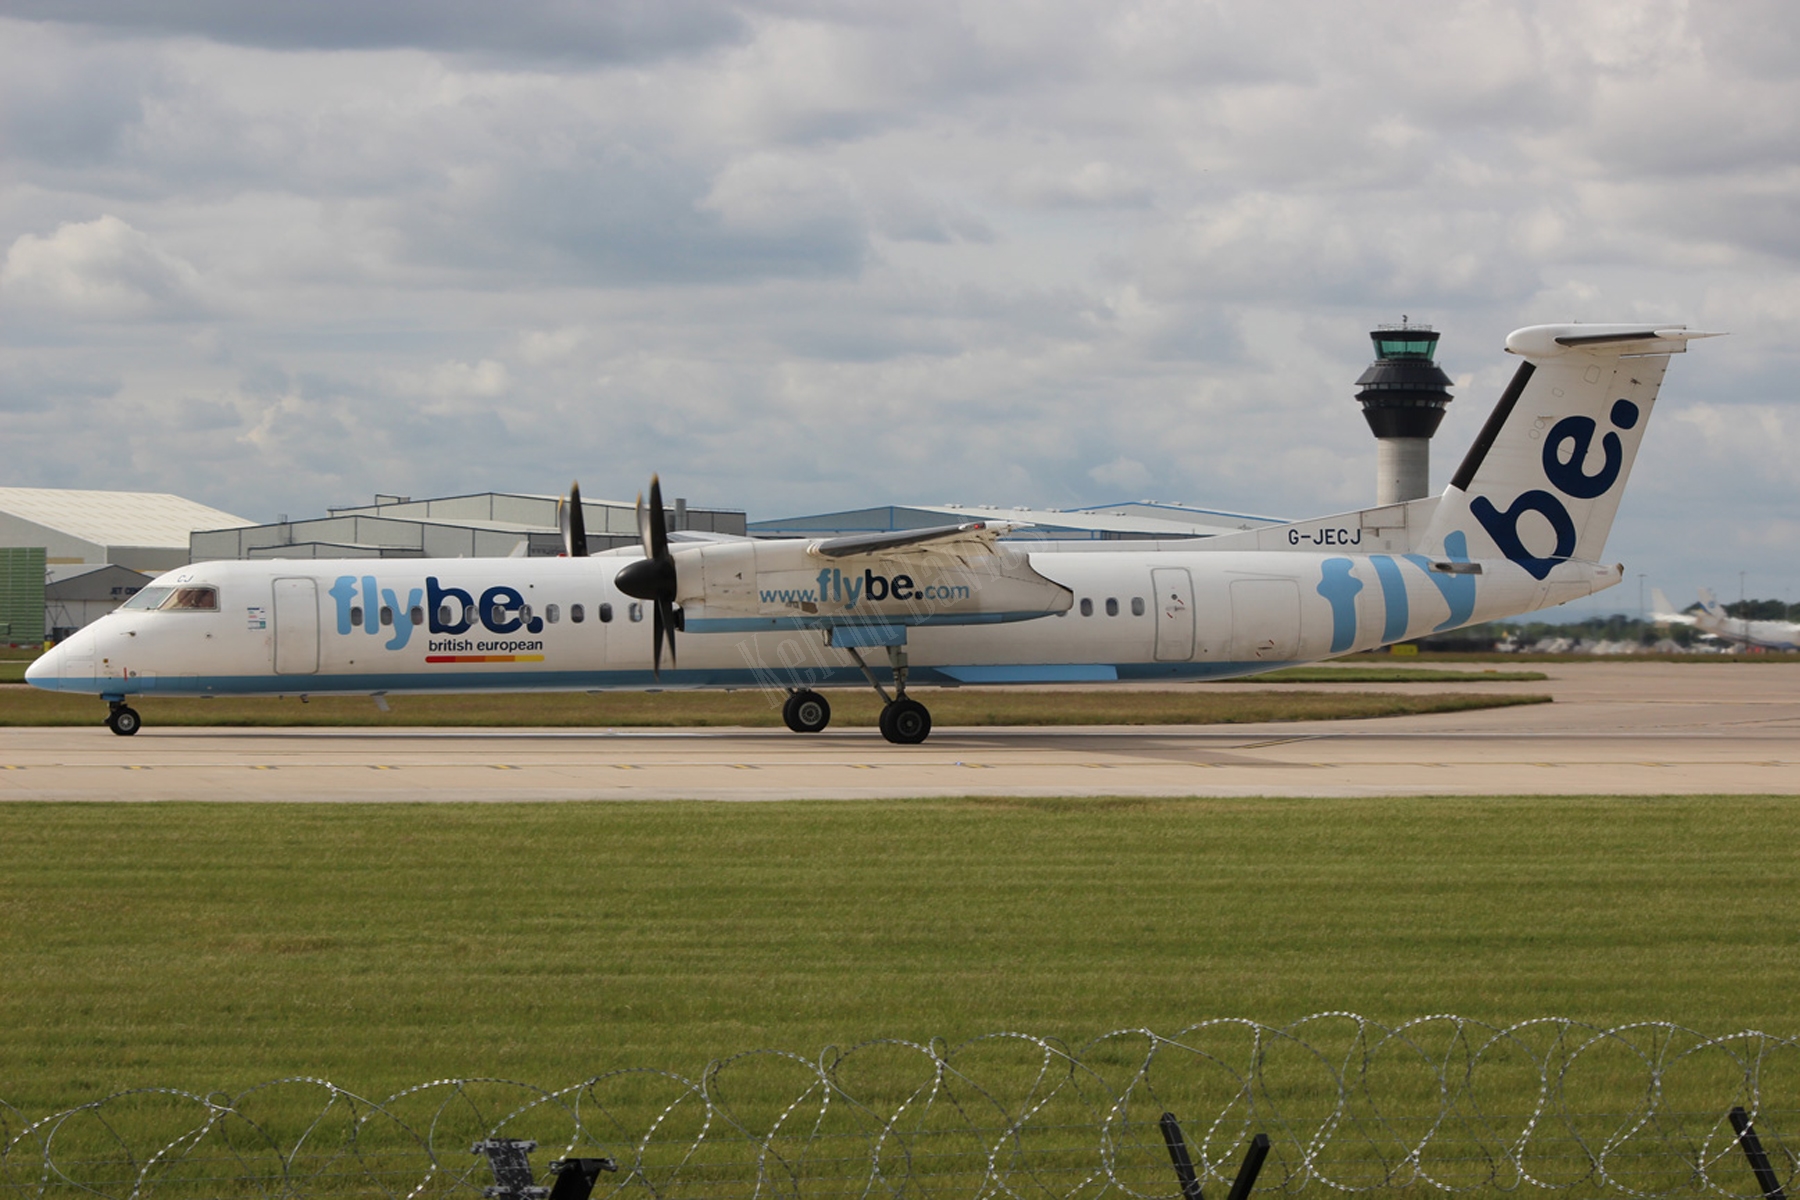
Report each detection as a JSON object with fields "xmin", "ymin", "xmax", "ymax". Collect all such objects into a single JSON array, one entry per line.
[{"xmin": 25, "ymin": 326, "xmax": 1712, "ymax": 745}]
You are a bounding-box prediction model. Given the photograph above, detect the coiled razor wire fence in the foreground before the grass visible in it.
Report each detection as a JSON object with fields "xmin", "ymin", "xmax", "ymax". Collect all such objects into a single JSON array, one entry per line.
[{"xmin": 0, "ymin": 1013, "xmax": 1800, "ymax": 1200}]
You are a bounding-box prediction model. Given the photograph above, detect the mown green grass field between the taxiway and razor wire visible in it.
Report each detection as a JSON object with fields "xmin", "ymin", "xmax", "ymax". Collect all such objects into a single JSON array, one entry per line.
[{"xmin": 0, "ymin": 797, "xmax": 1800, "ymax": 1114}]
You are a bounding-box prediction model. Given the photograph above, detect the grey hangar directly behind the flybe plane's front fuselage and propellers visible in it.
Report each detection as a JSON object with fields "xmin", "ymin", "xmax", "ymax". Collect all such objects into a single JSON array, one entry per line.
[{"xmin": 191, "ymin": 491, "xmax": 745, "ymax": 563}]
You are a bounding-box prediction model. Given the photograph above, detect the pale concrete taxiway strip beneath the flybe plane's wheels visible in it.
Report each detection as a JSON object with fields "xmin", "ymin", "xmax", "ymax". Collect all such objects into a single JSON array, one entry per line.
[{"xmin": 0, "ymin": 660, "xmax": 1800, "ymax": 801}]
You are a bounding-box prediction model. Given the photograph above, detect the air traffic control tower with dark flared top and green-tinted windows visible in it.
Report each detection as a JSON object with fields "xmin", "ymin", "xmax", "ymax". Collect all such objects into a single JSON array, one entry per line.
[{"xmin": 1357, "ymin": 317, "xmax": 1451, "ymax": 504}]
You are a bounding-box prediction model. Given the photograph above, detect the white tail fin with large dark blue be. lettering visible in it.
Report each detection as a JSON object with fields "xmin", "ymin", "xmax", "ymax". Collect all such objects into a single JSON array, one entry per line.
[{"xmin": 1418, "ymin": 326, "xmax": 1712, "ymax": 579}]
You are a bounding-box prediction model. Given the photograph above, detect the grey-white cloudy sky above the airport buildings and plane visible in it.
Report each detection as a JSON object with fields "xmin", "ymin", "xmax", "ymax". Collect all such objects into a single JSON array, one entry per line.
[{"xmin": 0, "ymin": 0, "xmax": 1800, "ymax": 615}]
